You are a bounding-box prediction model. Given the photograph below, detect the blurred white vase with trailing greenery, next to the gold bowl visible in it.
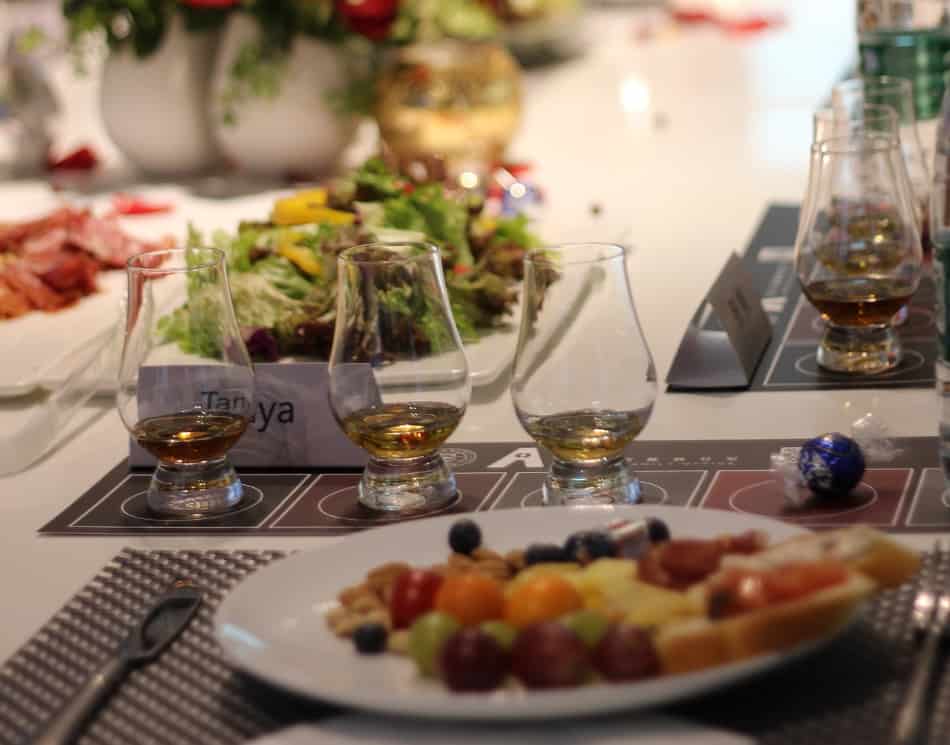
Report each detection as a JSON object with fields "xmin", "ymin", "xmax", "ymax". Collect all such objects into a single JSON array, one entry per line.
[{"xmin": 211, "ymin": 13, "xmax": 356, "ymax": 176}]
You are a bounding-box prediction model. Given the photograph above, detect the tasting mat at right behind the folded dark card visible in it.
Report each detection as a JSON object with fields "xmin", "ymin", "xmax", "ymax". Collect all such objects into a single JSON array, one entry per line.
[{"xmin": 670, "ymin": 205, "xmax": 937, "ymax": 391}]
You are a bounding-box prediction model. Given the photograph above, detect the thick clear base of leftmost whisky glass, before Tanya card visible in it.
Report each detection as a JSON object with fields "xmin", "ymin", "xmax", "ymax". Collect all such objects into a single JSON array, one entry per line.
[{"xmin": 146, "ymin": 458, "xmax": 243, "ymax": 518}]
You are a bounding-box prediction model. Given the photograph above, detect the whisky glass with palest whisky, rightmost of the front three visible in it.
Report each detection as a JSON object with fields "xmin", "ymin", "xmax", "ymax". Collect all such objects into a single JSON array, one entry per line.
[{"xmin": 511, "ymin": 243, "xmax": 657, "ymax": 505}]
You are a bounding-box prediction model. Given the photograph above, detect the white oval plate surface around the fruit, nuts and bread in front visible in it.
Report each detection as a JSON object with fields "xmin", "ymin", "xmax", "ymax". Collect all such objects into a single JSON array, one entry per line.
[{"xmin": 215, "ymin": 506, "xmax": 848, "ymax": 720}]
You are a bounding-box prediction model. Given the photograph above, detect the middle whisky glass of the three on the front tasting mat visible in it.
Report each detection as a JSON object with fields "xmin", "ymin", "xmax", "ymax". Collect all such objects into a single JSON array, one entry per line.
[{"xmin": 329, "ymin": 243, "xmax": 471, "ymax": 512}]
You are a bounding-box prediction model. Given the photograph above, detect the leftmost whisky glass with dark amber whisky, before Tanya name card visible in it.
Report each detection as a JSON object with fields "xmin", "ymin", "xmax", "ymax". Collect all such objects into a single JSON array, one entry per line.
[{"xmin": 117, "ymin": 248, "xmax": 254, "ymax": 518}]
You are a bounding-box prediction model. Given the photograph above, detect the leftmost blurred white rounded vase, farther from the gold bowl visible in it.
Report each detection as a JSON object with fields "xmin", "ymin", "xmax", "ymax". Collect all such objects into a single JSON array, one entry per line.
[{"xmin": 100, "ymin": 15, "xmax": 220, "ymax": 176}]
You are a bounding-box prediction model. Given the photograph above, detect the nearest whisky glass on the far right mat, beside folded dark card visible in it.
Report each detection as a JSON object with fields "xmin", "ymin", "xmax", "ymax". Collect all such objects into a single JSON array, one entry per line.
[{"xmin": 795, "ymin": 132, "xmax": 922, "ymax": 375}]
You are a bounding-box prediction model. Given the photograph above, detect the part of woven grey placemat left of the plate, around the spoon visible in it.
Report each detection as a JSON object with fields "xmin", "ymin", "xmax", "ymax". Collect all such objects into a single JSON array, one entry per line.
[{"xmin": 0, "ymin": 549, "xmax": 330, "ymax": 745}]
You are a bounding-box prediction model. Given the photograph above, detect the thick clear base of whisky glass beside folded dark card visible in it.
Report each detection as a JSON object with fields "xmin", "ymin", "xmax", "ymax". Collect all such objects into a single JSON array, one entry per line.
[{"xmin": 818, "ymin": 324, "xmax": 903, "ymax": 375}]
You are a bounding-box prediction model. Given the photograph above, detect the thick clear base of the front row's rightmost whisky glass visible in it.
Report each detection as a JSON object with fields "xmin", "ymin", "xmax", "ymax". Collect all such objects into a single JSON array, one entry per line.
[{"xmin": 541, "ymin": 457, "xmax": 640, "ymax": 505}]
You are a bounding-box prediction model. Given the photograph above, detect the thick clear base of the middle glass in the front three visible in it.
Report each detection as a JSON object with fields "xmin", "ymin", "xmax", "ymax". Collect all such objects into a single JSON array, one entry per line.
[{"xmin": 359, "ymin": 453, "xmax": 458, "ymax": 512}]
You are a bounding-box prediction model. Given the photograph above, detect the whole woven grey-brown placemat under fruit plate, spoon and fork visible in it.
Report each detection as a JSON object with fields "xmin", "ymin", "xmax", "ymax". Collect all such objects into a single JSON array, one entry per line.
[{"xmin": 0, "ymin": 549, "xmax": 950, "ymax": 745}]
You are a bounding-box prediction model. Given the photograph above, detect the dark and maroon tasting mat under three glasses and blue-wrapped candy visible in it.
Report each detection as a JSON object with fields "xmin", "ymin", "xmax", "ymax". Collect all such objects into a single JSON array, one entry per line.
[{"xmin": 40, "ymin": 437, "xmax": 950, "ymax": 536}]
